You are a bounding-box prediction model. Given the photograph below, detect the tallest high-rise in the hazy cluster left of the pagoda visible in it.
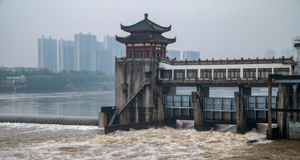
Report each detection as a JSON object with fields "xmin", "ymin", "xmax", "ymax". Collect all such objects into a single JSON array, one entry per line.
[{"xmin": 74, "ymin": 32, "xmax": 100, "ymax": 70}]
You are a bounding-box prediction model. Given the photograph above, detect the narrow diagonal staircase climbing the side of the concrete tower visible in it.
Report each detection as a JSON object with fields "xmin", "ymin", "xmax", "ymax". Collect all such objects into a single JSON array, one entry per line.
[{"xmin": 108, "ymin": 78, "xmax": 150, "ymax": 126}]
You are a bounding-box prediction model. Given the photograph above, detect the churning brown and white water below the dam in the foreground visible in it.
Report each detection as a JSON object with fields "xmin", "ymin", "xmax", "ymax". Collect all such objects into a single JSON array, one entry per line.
[{"xmin": 0, "ymin": 123, "xmax": 300, "ymax": 159}]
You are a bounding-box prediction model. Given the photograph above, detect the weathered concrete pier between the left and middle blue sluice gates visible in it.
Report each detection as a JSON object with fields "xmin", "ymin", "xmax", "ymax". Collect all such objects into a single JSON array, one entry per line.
[{"xmin": 192, "ymin": 92, "xmax": 204, "ymax": 131}]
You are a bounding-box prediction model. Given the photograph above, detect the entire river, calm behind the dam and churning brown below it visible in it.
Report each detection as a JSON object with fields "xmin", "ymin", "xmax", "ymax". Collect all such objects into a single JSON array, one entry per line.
[{"xmin": 0, "ymin": 89, "xmax": 300, "ymax": 160}]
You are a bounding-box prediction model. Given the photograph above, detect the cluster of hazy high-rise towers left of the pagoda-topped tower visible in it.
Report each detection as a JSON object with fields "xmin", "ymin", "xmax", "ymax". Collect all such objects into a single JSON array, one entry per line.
[{"xmin": 38, "ymin": 32, "xmax": 125, "ymax": 74}]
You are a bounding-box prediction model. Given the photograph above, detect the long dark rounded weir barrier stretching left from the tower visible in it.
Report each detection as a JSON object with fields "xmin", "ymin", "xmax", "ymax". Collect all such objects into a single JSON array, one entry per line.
[{"xmin": 0, "ymin": 115, "xmax": 98, "ymax": 126}]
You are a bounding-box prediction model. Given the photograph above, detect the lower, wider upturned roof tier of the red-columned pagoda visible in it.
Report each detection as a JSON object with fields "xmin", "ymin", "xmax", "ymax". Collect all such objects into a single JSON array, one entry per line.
[{"xmin": 116, "ymin": 35, "xmax": 176, "ymax": 44}]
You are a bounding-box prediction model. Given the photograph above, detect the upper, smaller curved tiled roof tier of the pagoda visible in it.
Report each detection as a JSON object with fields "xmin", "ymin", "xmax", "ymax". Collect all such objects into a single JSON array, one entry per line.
[{"xmin": 121, "ymin": 14, "xmax": 171, "ymax": 32}]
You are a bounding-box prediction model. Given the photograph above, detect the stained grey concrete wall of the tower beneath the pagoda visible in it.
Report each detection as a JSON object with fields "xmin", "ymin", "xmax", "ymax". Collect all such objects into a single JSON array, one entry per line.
[{"xmin": 115, "ymin": 58, "xmax": 161, "ymax": 124}]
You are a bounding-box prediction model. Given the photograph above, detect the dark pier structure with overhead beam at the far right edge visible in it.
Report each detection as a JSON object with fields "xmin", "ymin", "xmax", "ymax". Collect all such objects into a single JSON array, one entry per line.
[{"xmin": 267, "ymin": 75, "xmax": 300, "ymax": 139}]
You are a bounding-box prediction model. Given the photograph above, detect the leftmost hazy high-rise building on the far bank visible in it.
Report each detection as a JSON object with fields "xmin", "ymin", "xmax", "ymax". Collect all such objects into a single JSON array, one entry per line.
[{"xmin": 38, "ymin": 36, "xmax": 57, "ymax": 72}]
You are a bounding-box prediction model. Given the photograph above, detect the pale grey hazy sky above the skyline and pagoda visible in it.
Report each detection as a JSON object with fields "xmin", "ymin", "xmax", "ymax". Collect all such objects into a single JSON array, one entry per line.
[{"xmin": 0, "ymin": 0, "xmax": 300, "ymax": 67}]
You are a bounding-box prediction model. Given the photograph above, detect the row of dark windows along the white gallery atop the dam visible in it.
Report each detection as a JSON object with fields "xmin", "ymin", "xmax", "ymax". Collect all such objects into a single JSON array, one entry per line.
[{"xmin": 161, "ymin": 68, "xmax": 289, "ymax": 79}]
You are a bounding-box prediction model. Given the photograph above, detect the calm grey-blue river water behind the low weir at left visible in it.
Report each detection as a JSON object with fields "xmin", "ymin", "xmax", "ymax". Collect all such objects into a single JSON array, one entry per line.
[{"xmin": 0, "ymin": 91, "xmax": 115, "ymax": 117}]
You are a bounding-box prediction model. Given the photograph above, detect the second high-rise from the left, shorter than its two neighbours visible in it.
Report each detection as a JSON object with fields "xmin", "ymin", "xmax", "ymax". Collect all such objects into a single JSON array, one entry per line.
[{"xmin": 58, "ymin": 39, "xmax": 74, "ymax": 71}]
